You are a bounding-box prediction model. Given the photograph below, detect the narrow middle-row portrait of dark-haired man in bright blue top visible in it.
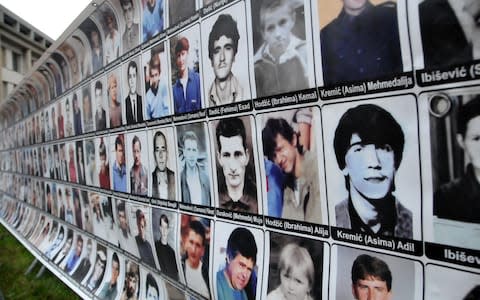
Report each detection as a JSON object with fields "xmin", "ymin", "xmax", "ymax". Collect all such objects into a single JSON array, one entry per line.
[{"xmin": 110, "ymin": 134, "xmax": 127, "ymax": 193}]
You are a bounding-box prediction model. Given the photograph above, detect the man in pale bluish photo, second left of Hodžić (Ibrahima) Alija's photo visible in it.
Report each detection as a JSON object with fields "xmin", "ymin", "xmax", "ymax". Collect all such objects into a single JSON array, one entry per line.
[{"xmin": 177, "ymin": 124, "xmax": 211, "ymax": 206}]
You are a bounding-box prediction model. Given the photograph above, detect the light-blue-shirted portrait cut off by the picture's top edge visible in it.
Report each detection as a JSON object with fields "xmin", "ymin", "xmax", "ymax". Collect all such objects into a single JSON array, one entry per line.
[{"xmin": 143, "ymin": 0, "xmax": 165, "ymax": 42}]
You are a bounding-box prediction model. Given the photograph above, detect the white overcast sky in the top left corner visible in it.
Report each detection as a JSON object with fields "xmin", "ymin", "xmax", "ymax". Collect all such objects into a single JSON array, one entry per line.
[{"xmin": 0, "ymin": 0, "xmax": 90, "ymax": 40}]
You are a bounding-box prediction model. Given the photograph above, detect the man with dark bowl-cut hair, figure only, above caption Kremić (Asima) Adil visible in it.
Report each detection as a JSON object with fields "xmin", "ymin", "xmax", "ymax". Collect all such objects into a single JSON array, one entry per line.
[{"xmin": 333, "ymin": 104, "xmax": 413, "ymax": 239}]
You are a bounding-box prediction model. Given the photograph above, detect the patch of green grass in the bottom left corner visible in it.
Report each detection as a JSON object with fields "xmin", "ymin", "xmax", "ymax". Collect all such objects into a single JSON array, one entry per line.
[{"xmin": 0, "ymin": 224, "xmax": 79, "ymax": 300}]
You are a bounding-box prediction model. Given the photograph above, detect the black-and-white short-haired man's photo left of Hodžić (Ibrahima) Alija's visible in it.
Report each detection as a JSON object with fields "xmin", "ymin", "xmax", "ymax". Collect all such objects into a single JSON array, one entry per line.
[{"xmin": 212, "ymin": 117, "xmax": 258, "ymax": 214}]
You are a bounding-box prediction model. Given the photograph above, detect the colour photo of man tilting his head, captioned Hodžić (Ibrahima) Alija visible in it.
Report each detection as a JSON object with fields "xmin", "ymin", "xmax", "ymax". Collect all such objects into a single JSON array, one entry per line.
[{"xmin": 260, "ymin": 108, "xmax": 324, "ymax": 224}]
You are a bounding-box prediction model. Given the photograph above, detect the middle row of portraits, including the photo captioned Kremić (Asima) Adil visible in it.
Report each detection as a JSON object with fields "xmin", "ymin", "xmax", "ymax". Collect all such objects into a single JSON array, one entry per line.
[{"xmin": 2, "ymin": 89, "xmax": 480, "ymax": 254}]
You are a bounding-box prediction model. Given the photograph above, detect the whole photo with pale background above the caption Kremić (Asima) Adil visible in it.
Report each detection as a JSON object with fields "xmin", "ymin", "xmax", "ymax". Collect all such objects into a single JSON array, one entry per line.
[{"xmin": 322, "ymin": 96, "xmax": 421, "ymax": 239}]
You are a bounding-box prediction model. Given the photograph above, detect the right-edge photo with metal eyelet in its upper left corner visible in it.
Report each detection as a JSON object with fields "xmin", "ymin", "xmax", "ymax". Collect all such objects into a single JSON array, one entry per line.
[{"xmin": 421, "ymin": 90, "xmax": 480, "ymax": 249}]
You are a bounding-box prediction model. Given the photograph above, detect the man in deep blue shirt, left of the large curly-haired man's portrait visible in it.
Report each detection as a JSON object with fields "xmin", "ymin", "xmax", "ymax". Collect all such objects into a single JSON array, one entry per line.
[{"xmin": 171, "ymin": 34, "xmax": 202, "ymax": 114}]
